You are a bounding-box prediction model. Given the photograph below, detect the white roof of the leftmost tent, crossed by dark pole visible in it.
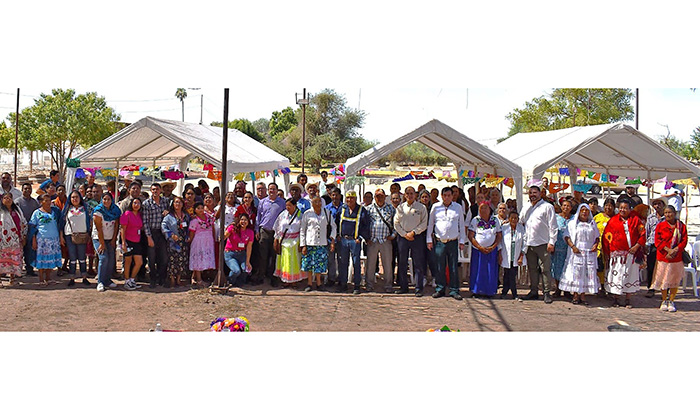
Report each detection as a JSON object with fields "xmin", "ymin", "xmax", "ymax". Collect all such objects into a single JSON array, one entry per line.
[{"xmin": 77, "ymin": 117, "xmax": 289, "ymax": 174}]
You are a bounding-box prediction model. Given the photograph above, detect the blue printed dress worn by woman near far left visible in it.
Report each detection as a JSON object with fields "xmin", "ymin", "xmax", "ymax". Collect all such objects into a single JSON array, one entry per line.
[{"xmin": 29, "ymin": 208, "xmax": 63, "ymax": 270}]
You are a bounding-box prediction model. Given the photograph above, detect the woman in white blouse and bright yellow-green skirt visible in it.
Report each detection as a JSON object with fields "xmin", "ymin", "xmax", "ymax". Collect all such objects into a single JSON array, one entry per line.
[{"xmin": 274, "ymin": 198, "xmax": 305, "ymax": 287}]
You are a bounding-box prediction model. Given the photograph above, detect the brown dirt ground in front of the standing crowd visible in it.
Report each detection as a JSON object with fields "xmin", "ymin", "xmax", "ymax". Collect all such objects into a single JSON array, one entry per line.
[{"xmin": 0, "ymin": 277, "xmax": 700, "ymax": 332}]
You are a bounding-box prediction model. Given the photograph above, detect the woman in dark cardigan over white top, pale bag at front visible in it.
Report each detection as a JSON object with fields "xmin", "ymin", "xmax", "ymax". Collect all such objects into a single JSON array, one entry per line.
[{"xmin": 58, "ymin": 191, "xmax": 92, "ymax": 286}]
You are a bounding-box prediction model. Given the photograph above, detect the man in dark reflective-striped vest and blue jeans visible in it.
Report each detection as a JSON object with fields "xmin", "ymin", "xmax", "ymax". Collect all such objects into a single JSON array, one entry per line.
[{"xmin": 335, "ymin": 190, "xmax": 370, "ymax": 295}]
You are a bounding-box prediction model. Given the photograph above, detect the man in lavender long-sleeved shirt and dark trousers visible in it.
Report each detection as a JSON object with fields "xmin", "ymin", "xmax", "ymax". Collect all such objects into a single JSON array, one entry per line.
[{"xmin": 255, "ymin": 182, "xmax": 285, "ymax": 286}]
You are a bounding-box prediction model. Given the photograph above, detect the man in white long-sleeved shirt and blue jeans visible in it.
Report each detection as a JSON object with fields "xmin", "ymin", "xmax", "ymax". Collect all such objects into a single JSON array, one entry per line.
[{"xmin": 426, "ymin": 187, "xmax": 467, "ymax": 300}]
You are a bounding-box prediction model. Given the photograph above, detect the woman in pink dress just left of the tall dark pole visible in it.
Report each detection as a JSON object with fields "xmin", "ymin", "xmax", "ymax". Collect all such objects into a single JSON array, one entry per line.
[{"xmin": 189, "ymin": 203, "xmax": 216, "ymax": 287}]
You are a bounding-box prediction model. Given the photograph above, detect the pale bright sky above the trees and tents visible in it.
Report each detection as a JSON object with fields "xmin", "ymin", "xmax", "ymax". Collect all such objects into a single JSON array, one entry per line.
[{"xmin": 0, "ymin": 84, "xmax": 700, "ymax": 144}]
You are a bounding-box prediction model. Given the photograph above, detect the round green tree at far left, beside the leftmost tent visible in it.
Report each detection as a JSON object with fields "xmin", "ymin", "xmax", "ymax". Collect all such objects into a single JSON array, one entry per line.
[{"xmin": 8, "ymin": 89, "xmax": 120, "ymax": 177}]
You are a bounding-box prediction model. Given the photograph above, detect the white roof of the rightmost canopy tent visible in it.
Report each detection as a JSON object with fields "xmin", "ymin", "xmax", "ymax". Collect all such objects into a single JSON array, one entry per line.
[{"xmin": 495, "ymin": 123, "xmax": 700, "ymax": 180}]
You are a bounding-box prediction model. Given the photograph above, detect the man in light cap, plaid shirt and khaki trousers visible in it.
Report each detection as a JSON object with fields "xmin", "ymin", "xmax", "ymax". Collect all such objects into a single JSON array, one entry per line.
[{"xmin": 365, "ymin": 188, "xmax": 396, "ymax": 292}]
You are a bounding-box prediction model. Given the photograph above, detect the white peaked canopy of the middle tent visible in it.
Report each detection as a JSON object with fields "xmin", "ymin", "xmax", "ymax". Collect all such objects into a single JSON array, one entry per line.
[{"xmin": 345, "ymin": 120, "xmax": 523, "ymax": 207}]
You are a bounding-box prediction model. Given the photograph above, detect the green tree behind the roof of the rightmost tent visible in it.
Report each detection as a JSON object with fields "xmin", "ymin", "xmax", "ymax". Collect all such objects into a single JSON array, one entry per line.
[{"xmin": 506, "ymin": 88, "xmax": 634, "ymax": 136}]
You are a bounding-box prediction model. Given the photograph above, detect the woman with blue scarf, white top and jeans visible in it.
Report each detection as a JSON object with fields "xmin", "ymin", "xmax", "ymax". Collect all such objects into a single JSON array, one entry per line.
[{"xmin": 92, "ymin": 192, "xmax": 122, "ymax": 292}]
